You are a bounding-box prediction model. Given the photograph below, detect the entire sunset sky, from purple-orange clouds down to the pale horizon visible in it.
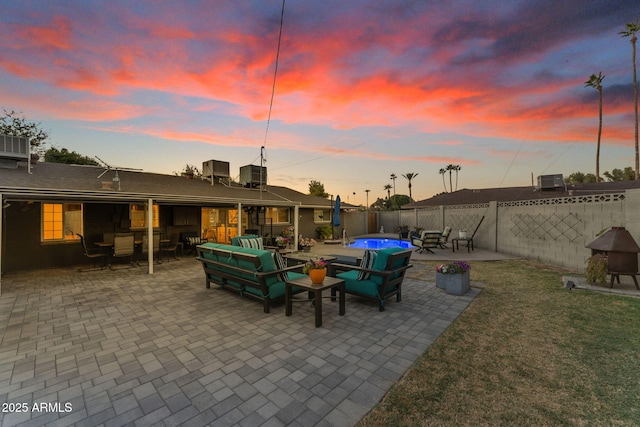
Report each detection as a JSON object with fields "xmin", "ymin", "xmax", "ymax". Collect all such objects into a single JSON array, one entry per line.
[{"xmin": 0, "ymin": 0, "xmax": 640, "ymax": 204}]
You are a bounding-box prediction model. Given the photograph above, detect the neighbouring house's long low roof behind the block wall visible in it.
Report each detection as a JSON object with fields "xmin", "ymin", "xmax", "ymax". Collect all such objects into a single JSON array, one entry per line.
[{"xmin": 402, "ymin": 181, "xmax": 640, "ymax": 209}]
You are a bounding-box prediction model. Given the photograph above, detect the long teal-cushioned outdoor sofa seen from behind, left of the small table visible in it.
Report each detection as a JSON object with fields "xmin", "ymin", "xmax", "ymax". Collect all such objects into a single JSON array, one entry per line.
[{"xmin": 196, "ymin": 243, "xmax": 304, "ymax": 313}]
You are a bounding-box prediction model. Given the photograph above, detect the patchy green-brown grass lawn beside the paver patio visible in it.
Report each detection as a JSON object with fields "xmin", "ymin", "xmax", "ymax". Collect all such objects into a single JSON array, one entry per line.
[{"xmin": 359, "ymin": 260, "xmax": 640, "ymax": 426}]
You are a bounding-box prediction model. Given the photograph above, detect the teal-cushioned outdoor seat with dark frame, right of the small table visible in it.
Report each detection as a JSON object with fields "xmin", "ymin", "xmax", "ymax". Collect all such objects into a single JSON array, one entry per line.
[{"xmin": 330, "ymin": 247, "xmax": 412, "ymax": 311}]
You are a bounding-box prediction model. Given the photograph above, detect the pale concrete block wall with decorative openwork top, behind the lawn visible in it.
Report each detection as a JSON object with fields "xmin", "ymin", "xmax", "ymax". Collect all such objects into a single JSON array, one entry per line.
[{"xmin": 392, "ymin": 189, "xmax": 640, "ymax": 272}]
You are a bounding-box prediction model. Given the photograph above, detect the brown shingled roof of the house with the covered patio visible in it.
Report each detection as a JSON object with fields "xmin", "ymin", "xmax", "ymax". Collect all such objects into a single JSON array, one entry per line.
[{"xmin": 0, "ymin": 162, "xmax": 350, "ymax": 208}]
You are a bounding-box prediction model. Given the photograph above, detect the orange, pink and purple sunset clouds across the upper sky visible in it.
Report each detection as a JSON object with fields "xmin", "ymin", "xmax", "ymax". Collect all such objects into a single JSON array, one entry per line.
[{"xmin": 0, "ymin": 0, "xmax": 637, "ymax": 163}]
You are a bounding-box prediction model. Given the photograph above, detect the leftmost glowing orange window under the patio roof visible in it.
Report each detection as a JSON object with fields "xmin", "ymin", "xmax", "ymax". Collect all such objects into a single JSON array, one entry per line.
[{"xmin": 42, "ymin": 203, "xmax": 83, "ymax": 242}]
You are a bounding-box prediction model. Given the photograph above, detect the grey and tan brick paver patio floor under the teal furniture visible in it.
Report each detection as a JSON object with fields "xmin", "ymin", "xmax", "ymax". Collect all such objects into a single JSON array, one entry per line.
[{"xmin": 0, "ymin": 258, "xmax": 480, "ymax": 426}]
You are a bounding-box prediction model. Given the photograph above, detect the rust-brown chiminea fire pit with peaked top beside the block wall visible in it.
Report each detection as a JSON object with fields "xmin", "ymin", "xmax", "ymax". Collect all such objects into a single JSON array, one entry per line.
[{"xmin": 586, "ymin": 227, "xmax": 640, "ymax": 290}]
